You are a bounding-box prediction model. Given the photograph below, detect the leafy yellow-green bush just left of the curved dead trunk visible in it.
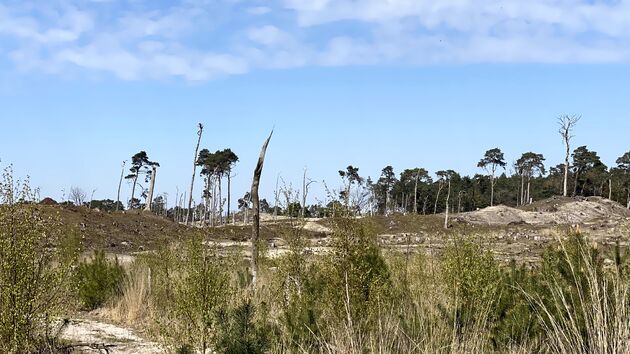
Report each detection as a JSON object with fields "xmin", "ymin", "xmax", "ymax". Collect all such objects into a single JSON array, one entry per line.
[{"xmin": 147, "ymin": 233, "xmax": 233, "ymax": 352}]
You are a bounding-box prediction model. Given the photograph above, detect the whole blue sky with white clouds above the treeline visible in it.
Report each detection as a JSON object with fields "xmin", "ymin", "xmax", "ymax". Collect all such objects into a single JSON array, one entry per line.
[{"xmin": 0, "ymin": 0, "xmax": 630, "ymax": 209}]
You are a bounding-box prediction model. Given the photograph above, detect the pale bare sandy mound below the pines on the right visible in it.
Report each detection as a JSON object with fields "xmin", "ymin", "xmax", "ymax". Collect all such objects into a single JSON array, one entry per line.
[{"xmin": 456, "ymin": 197, "xmax": 630, "ymax": 225}]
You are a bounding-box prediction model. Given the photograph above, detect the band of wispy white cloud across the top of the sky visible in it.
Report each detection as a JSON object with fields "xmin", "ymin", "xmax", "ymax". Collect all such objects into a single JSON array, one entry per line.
[{"xmin": 0, "ymin": 0, "xmax": 630, "ymax": 80}]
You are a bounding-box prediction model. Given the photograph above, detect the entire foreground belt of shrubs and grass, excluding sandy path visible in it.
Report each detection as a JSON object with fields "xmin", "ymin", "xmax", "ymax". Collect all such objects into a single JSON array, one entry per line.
[{"xmin": 0, "ymin": 167, "xmax": 630, "ymax": 353}]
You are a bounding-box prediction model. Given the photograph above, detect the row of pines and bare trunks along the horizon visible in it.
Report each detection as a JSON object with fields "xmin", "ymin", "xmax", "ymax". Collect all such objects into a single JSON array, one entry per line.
[{"xmin": 12, "ymin": 116, "xmax": 630, "ymax": 225}]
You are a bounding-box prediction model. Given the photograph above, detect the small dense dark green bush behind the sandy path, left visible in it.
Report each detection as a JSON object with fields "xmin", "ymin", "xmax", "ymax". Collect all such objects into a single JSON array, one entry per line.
[{"xmin": 76, "ymin": 250, "xmax": 125, "ymax": 310}]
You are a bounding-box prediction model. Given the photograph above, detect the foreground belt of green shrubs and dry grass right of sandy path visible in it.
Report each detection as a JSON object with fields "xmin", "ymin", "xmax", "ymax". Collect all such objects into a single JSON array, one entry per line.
[{"xmin": 92, "ymin": 219, "xmax": 630, "ymax": 353}]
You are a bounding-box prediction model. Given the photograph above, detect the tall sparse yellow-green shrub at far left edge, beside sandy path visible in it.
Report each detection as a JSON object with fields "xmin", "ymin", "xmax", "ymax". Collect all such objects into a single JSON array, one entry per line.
[{"xmin": 0, "ymin": 168, "xmax": 78, "ymax": 353}]
